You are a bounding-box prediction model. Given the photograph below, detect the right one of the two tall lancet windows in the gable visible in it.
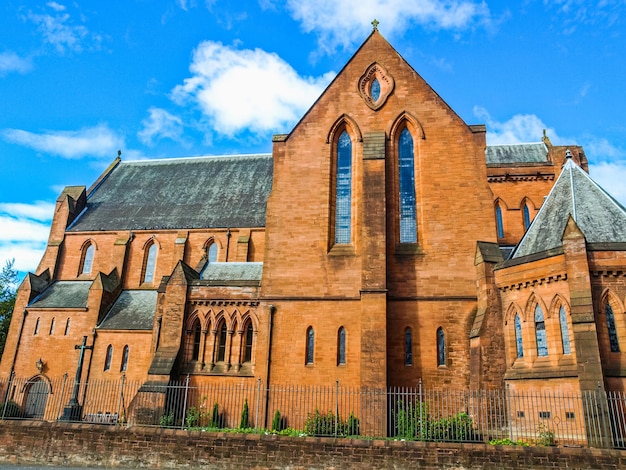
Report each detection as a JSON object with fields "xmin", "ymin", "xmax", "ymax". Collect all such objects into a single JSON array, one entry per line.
[{"xmin": 398, "ymin": 127, "xmax": 417, "ymax": 243}]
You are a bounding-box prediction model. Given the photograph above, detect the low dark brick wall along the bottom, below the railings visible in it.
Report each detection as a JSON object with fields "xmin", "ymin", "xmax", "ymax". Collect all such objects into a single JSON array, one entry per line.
[{"xmin": 0, "ymin": 421, "xmax": 626, "ymax": 470}]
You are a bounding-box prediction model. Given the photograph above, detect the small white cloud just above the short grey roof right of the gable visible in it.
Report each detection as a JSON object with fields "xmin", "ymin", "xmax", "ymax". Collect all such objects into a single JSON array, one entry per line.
[{"xmin": 474, "ymin": 106, "xmax": 556, "ymax": 145}]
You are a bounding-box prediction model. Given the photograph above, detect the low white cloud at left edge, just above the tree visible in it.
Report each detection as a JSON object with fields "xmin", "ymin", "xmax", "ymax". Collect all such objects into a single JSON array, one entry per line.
[{"xmin": 0, "ymin": 201, "xmax": 54, "ymax": 272}]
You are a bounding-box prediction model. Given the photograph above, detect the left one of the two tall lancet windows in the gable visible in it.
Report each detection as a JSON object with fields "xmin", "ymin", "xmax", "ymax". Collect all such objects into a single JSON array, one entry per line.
[{"xmin": 335, "ymin": 131, "xmax": 352, "ymax": 243}]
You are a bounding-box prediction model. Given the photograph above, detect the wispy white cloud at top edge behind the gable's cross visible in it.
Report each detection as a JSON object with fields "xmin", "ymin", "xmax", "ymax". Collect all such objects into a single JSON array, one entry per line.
[{"xmin": 287, "ymin": 0, "xmax": 490, "ymax": 52}]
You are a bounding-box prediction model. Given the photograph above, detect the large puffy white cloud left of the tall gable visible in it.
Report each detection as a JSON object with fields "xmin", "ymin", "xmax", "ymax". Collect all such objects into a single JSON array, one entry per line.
[{"xmin": 172, "ymin": 41, "xmax": 334, "ymax": 136}]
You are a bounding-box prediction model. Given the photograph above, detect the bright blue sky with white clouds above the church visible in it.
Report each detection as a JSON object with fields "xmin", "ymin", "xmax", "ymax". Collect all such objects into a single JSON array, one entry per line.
[{"xmin": 0, "ymin": 0, "xmax": 626, "ymax": 271}]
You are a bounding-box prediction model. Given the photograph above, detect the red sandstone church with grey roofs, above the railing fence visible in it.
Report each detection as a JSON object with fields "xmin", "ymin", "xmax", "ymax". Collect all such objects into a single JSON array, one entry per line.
[{"xmin": 0, "ymin": 28, "xmax": 626, "ymax": 422}]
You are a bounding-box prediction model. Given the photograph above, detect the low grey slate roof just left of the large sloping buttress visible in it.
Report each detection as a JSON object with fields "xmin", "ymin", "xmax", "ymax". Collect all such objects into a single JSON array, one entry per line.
[{"xmin": 98, "ymin": 290, "xmax": 157, "ymax": 330}]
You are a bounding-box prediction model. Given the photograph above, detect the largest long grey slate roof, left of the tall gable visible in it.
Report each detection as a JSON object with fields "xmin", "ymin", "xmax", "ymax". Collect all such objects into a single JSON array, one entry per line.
[{"xmin": 68, "ymin": 154, "xmax": 273, "ymax": 232}]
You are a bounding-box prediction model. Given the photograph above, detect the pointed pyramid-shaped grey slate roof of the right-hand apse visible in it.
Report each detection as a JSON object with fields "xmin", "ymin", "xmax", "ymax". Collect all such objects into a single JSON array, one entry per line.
[{"xmin": 511, "ymin": 158, "xmax": 626, "ymax": 259}]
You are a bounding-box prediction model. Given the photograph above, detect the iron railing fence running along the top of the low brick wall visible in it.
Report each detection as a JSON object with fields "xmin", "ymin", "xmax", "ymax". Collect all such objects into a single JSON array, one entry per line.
[{"xmin": 0, "ymin": 376, "xmax": 626, "ymax": 448}]
